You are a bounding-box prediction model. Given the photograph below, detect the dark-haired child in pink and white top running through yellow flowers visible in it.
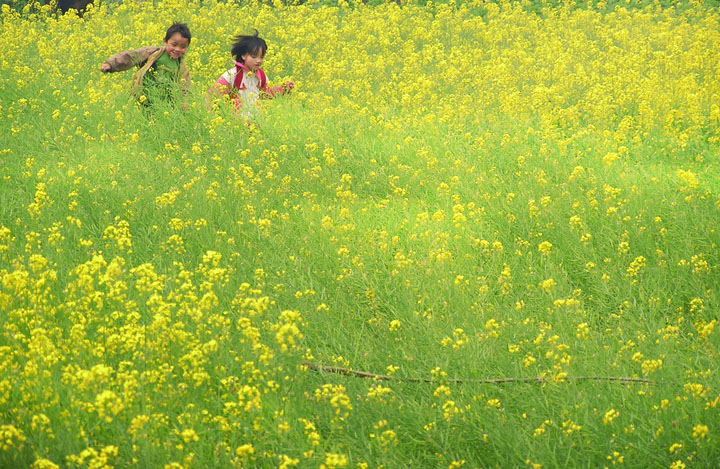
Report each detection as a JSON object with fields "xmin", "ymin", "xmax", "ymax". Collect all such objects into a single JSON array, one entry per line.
[{"xmin": 211, "ymin": 30, "xmax": 294, "ymax": 113}]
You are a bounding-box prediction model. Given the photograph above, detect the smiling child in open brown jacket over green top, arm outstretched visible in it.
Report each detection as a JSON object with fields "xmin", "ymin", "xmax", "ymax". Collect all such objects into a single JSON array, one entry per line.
[{"xmin": 100, "ymin": 23, "xmax": 191, "ymax": 105}]
